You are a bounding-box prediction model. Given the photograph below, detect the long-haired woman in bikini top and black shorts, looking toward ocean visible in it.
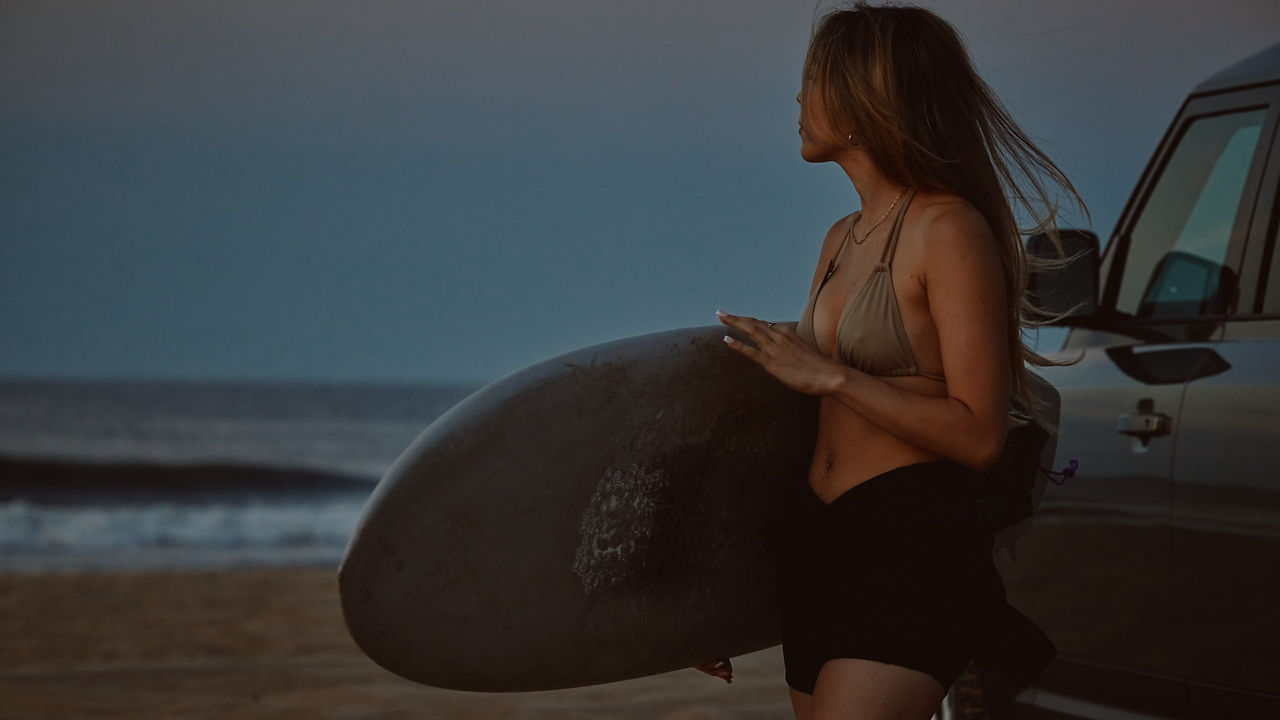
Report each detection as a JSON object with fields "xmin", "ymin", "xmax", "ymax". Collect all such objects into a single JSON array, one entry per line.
[{"xmin": 701, "ymin": 3, "xmax": 1083, "ymax": 720}]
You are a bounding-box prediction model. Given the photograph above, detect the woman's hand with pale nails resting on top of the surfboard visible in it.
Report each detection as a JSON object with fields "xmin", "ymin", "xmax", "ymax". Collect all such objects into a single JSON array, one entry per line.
[{"xmin": 716, "ymin": 310, "xmax": 844, "ymax": 395}]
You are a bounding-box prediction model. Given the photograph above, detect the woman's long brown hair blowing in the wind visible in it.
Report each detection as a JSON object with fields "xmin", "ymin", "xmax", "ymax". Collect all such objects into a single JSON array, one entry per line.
[{"xmin": 801, "ymin": 1, "xmax": 1088, "ymax": 421}]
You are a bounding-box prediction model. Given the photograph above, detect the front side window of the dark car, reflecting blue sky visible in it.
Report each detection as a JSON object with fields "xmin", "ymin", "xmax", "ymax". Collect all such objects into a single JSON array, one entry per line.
[{"xmin": 1116, "ymin": 109, "xmax": 1266, "ymax": 318}]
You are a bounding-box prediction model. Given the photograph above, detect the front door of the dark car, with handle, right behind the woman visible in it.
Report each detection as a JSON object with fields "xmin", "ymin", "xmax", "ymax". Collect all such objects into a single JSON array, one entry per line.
[{"xmin": 1001, "ymin": 87, "xmax": 1270, "ymax": 717}]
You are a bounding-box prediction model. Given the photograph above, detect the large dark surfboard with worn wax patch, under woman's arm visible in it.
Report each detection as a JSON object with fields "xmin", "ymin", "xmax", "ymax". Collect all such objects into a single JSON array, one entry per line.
[{"xmin": 339, "ymin": 325, "xmax": 1056, "ymax": 692}]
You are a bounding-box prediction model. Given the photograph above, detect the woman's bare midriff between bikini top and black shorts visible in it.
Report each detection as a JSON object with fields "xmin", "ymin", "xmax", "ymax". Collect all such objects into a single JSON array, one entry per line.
[{"xmin": 809, "ymin": 375, "xmax": 947, "ymax": 503}]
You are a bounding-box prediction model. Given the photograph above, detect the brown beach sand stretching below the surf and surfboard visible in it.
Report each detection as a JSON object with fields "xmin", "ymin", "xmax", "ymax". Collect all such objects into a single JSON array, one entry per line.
[{"xmin": 0, "ymin": 568, "xmax": 791, "ymax": 720}]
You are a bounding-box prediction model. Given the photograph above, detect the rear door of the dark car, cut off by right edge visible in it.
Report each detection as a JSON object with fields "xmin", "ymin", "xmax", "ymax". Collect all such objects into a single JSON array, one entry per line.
[{"xmin": 1171, "ymin": 86, "xmax": 1280, "ymax": 717}]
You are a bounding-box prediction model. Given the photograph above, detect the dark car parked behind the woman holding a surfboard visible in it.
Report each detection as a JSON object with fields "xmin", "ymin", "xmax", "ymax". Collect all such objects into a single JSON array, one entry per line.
[{"xmin": 941, "ymin": 44, "xmax": 1280, "ymax": 719}]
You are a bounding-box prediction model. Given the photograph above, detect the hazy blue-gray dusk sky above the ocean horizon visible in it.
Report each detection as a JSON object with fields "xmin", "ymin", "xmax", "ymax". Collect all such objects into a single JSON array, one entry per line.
[{"xmin": 0, "ymin": 0, "xmax": 1280, "ymax": 382}]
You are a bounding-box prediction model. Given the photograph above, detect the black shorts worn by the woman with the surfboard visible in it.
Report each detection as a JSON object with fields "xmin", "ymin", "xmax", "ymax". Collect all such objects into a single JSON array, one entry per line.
[{"xmin": 782, "ymin": 461, "xmax": 1029, "ymax": 694}]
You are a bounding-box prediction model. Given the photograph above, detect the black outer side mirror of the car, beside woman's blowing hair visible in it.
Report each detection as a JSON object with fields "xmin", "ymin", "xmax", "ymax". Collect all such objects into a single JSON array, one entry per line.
[{"xmin": 1027, "ymin": 229, "xmax": 1098, "ymax": 325}]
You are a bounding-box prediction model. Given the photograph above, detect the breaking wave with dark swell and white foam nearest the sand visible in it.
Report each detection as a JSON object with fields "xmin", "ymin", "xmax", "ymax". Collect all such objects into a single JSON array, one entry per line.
[{"xmin": 0, "ymin": 457, "xmax": 374, "ymax": 570}]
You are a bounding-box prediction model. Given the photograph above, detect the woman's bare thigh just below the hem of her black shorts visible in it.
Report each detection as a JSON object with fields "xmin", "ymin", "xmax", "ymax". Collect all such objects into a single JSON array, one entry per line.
[{"xmin": 791, "ymin": 657, "xmax": 946, "ymax": 720}]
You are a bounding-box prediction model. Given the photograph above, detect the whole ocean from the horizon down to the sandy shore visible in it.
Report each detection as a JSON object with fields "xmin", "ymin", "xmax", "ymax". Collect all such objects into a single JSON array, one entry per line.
[{"xmin": 0, "ymin": 380, "xmax": 476, "ymax": 571}]
